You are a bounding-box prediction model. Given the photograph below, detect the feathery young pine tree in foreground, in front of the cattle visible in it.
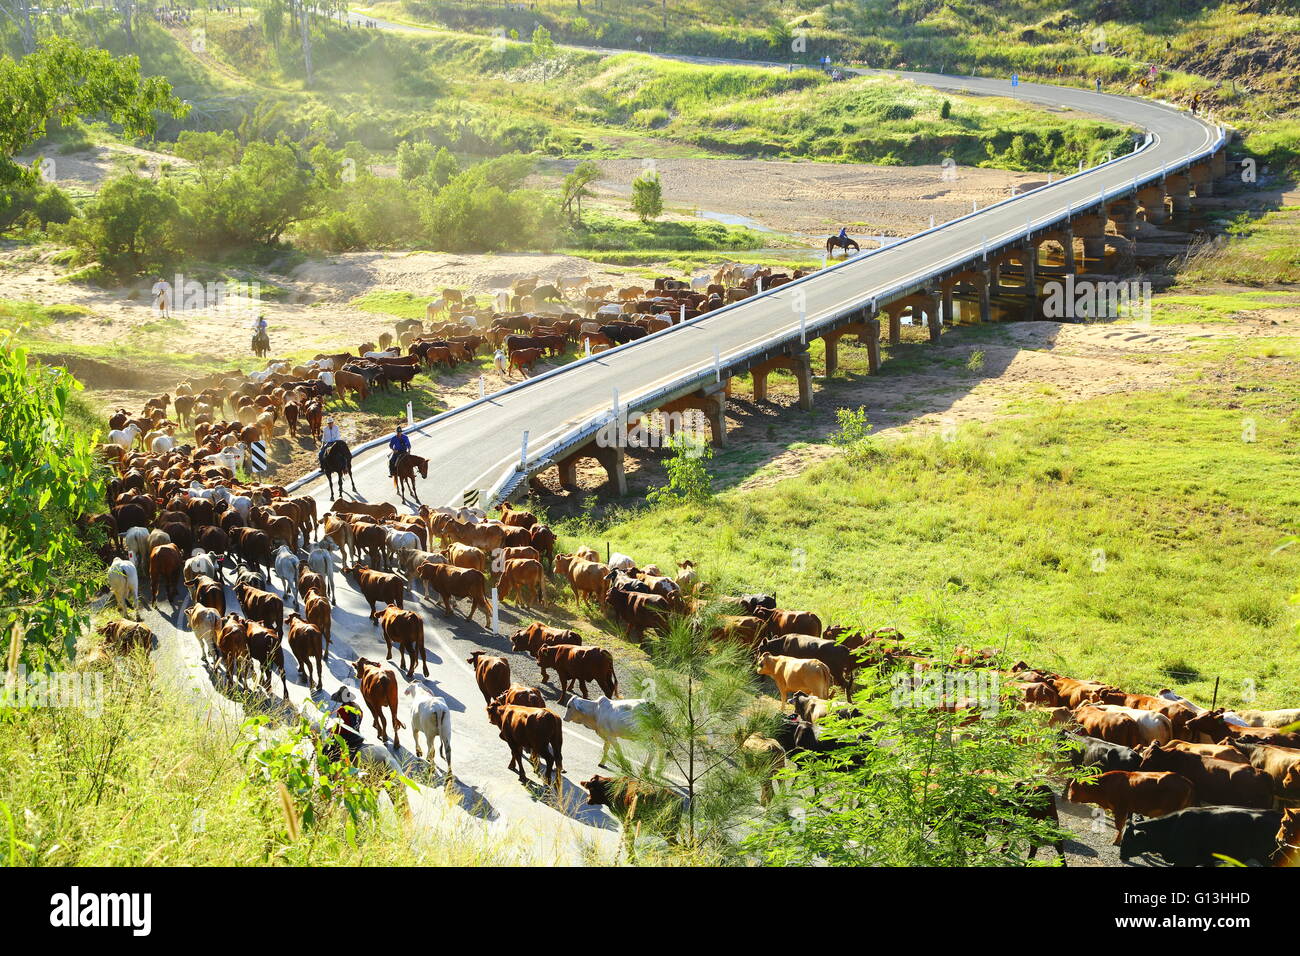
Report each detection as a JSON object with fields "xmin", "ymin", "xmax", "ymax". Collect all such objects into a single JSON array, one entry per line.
[{"xmin": 611, "ymin": 611, "xmax": 775, "ymax": 858}]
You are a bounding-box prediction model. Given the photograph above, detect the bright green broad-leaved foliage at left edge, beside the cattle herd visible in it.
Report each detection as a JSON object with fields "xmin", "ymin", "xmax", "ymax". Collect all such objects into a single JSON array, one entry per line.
[{"xmin": 0, "ymin": 330, "xmax": 103, "ymax": 669}]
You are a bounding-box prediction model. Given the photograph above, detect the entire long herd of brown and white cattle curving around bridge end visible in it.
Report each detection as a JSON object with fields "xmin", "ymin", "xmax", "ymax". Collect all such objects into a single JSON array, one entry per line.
[{"xmin": 76, "ymin": 267, "xmax": 1300, "ymax": 865}]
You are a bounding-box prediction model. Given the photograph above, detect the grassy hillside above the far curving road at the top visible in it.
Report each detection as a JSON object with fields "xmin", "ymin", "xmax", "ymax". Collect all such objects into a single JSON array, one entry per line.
[{"xmin": 369, "ymin": 0, "xmax": 1300, "ymax": 165}]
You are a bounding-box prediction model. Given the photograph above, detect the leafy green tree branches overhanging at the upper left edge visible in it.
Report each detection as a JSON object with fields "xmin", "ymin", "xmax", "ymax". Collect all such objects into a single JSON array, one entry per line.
[{"xmin": 0, "ymin": 36, "xmax": 189, "ymax": 189}]
